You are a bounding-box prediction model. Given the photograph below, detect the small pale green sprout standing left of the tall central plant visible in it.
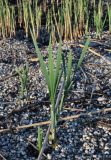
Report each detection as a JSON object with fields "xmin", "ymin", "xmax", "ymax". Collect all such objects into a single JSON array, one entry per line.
[{"xmin": 16, "ymin": 64, "xmax": 29, "ymax": 98}]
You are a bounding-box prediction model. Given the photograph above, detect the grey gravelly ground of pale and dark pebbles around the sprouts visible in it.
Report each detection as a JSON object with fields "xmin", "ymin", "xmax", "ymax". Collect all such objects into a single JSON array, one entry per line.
[{"xmin": 0, "ymin": 35, "xmax": 111, "ymax": 160}]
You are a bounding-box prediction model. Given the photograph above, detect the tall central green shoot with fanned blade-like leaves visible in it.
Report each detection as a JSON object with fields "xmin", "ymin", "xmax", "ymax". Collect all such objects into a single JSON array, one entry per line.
[{"xmin": 31, "ymin": 28, "xmax": 62, "ymax": 139}]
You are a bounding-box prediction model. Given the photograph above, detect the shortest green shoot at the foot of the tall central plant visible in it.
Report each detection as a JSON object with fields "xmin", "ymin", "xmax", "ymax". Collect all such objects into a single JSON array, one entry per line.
[{"xmin": 37, "ymin": 127, "xmax": 43, "ymax": 152}]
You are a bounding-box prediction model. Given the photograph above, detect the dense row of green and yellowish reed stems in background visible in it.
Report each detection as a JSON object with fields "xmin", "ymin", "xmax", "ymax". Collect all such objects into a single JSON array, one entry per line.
[{"xmin": 0, "ymin": 0, "xmax": 111, "ymax": 41}]
